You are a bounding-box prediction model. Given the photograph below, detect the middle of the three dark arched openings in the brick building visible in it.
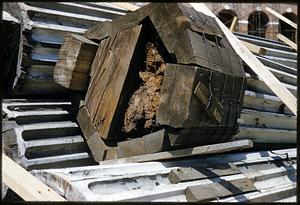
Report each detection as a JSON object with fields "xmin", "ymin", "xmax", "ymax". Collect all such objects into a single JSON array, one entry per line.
[{"xmin": 248, "ymin": 11, "xmax": 269, "ymax": 37}]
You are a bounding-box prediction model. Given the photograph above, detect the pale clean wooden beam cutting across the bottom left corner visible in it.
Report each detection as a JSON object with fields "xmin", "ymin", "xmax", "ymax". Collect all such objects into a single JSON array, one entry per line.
[{"xmin": 2, "ymin": 153, "xmax": 66, "ymax": 201}]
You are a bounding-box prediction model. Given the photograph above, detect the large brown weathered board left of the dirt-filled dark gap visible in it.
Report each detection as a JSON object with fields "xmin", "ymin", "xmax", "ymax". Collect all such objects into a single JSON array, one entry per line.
[{"xmin": 85, "ymin": 26, "xmax": 141, "ymax": 139}]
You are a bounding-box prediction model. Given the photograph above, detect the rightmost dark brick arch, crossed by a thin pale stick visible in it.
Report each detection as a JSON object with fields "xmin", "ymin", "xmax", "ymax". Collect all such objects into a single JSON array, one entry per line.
[{"xmin": 278, "ymin": 13, "xmax": 297, "ymax": 42}]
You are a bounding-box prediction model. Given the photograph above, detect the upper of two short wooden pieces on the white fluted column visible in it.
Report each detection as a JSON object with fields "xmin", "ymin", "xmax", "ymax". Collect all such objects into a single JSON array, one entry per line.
[{"xmin": 168, "ymin": 164, "xmax": 241, "ymax": 184}]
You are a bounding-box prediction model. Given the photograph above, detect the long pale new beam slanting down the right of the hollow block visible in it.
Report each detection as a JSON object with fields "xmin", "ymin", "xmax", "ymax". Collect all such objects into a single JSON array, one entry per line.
[{"xmin": 191, "ymin": 3, "xmax": 297, "ymax": 115}]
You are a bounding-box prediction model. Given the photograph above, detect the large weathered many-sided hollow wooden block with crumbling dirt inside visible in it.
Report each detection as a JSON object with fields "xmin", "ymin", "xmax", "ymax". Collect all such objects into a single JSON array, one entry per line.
[{"xmin": 72, "ymin": 4, "xmax": 246, "ymax": 161}]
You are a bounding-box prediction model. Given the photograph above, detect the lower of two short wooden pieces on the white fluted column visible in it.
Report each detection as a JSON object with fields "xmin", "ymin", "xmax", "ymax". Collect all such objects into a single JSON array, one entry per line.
[{"xmin": 185, "ymin": 178, "xmax": 257, "ymax": 202}]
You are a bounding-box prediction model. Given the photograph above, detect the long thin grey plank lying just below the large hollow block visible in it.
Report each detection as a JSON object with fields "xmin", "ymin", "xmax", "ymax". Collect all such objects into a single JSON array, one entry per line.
[{"xmin": 99, "ymin": 140, "xmax": 253, "ymax": 165}]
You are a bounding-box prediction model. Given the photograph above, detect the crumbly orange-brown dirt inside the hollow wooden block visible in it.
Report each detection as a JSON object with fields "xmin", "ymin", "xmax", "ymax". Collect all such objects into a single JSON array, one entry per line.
[{"xmin": 123, "ymin": 43, "xmax": 165, "ymax": 133}]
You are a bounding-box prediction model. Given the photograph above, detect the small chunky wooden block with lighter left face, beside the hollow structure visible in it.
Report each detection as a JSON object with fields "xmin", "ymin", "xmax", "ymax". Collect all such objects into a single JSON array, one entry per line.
[{"xmin": 53, "ymin": 34, "xmax": 98, "ymax": 91}]
